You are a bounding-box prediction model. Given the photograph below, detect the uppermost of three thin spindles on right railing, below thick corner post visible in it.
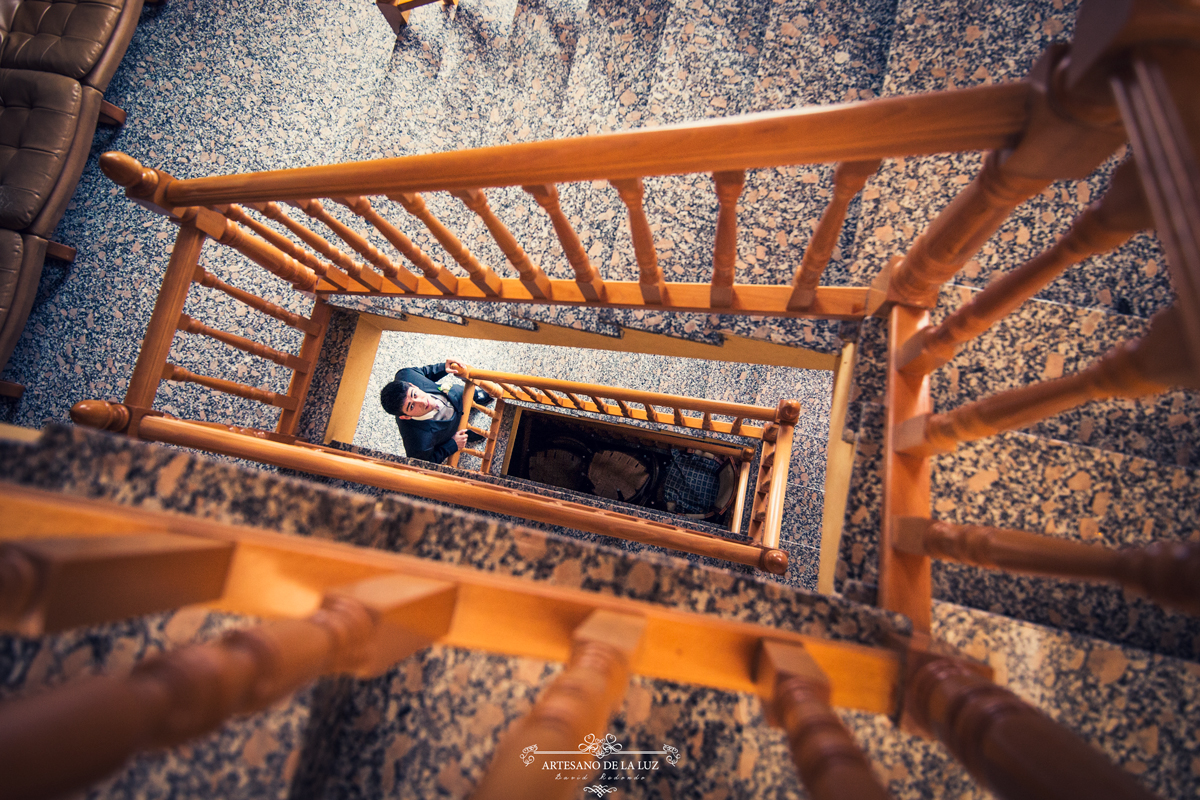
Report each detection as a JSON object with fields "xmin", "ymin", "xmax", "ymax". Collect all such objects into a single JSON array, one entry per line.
[{"xmin": 896, "ymin": 161, "xmax": 1153, "ymax": 375}]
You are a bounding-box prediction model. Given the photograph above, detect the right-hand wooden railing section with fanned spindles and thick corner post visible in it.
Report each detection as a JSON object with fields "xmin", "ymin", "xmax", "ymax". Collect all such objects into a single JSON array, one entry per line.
[{"xmin": 871, "ymin": 0, "xmax": 1200, "ymax": 642}]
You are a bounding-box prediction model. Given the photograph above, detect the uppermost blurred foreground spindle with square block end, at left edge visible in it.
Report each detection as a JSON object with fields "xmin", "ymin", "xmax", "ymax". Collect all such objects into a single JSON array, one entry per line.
[{"xmin": 0, "ymin": 534, "xmax": 234, "ymax": 636}]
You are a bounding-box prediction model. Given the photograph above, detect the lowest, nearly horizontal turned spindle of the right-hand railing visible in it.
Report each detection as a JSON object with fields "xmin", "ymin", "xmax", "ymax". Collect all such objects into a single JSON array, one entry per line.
[{"xmin": 894, "ymin": 517, "xmax": 1200, "ymax": 614}]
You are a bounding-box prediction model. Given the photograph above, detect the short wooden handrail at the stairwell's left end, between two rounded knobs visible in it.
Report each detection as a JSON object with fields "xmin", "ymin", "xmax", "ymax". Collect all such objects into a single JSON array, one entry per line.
[{"xmin": 125, "ymin": 226, "xmax": 205, "ymax": 408}]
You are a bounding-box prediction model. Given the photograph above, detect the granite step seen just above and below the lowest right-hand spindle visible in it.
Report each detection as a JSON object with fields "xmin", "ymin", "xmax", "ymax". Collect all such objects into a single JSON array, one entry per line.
[{"xmin": 838, "ymin": 404, "xmax": 1200, "ymax": 660}]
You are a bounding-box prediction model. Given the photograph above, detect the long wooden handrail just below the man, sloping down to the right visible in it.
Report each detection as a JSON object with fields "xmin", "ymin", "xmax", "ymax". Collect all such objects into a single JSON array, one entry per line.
[{"xmin": 77, "ymin": 412, "xmax": 787, "ymax": 575}]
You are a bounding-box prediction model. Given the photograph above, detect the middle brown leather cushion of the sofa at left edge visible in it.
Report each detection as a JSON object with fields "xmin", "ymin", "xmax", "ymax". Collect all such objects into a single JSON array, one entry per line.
[{"xmin": 0, "ymin": 70, "xmax": 83, "ymax": 230}]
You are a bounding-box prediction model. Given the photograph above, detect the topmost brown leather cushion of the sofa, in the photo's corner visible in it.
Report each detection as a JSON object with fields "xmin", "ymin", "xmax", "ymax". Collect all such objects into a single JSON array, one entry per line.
[{"xmin": 0, "ymin": 0, "xmax": 125, "ymax": 80}]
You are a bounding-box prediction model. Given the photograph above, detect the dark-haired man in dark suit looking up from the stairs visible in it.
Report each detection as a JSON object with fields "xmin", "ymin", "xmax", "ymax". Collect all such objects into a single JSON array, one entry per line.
[{"xmin": 379, "ymin": 359, "xmax": 492, "ymax": 464}]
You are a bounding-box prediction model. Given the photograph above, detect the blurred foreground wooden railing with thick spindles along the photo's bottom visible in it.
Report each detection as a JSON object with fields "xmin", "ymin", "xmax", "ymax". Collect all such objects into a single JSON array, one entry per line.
[{"xmin": 0, "ymin": 483, "xmax": 1166, "ymax": 800}]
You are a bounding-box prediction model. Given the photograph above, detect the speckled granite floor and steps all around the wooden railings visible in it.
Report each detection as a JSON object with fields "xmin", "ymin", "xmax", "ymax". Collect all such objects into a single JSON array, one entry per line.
[{"xmin": 0, "ymin": 0, "xmax": 1200, "ymax": 800}]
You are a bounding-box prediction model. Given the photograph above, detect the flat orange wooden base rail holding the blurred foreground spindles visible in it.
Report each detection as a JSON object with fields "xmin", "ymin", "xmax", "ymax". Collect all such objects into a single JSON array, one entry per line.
[{"xmin": 0, "ymin": 483, "xmax": 900, "ymax": 714}]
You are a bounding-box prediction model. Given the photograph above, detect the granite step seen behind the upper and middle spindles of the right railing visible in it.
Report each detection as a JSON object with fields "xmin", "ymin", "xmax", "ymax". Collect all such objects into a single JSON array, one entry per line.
[{"xmin": 847, "ymin": 287, "xmax": 1200, "ymax": 468}]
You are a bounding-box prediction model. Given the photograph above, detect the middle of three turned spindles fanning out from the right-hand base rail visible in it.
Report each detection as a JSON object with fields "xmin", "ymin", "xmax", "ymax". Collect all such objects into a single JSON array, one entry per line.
[{"xmin": 894, "ymin": 307, "xmax": 1200, "ymax": 456}]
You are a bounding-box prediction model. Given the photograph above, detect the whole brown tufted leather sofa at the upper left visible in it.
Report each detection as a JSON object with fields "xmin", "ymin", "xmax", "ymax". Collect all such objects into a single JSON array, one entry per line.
[{"xmin": 0, "ymin": 0, "xmax": 142, "ymax": 397}]
